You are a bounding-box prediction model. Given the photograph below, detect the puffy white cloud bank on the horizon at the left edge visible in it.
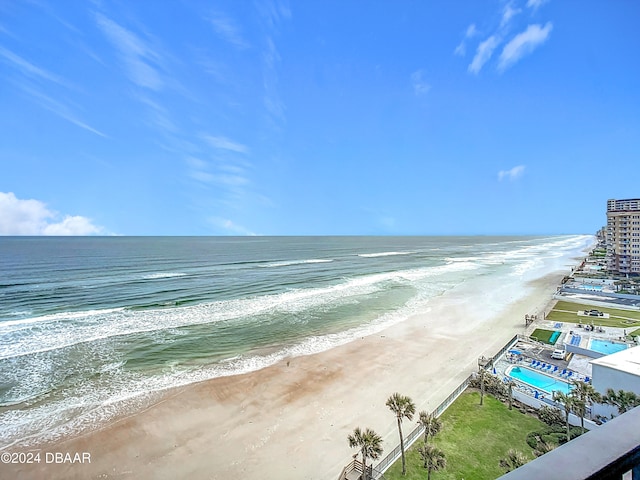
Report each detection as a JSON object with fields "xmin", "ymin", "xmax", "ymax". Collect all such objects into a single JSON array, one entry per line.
[{"xmin": 0, "ymin": 192, "xmax": 104, "ymax": 235}]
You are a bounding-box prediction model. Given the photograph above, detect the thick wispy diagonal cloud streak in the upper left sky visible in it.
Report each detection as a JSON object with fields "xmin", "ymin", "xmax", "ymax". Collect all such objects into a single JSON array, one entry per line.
[{"xmin": 96, "ymin": 13, "xmax": 165, "ymax": 90}]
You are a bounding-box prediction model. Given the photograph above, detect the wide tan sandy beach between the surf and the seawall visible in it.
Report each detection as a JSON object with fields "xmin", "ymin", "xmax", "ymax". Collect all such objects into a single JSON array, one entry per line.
[{"xmin": 5, "ymin": 272, "xmax": 565, "ymax": 480}]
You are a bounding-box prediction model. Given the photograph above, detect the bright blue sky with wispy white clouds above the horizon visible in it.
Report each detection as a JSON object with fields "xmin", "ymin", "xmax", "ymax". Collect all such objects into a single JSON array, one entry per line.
[{"xmin": 0, "ymin": 0, "xmax": 640, "ymax": 235}]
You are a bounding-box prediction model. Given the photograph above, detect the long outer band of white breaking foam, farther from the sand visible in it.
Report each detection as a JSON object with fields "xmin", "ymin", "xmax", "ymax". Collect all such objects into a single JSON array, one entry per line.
[{"xmin": 0, "ymin": 262, "xmax": 470, "ymax": 359}]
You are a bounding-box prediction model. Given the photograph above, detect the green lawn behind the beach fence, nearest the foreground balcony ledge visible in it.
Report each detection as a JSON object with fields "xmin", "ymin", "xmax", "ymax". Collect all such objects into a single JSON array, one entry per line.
[{"xmin": 384, "ymin": 391, "xmax": 545, "ymax": 480}]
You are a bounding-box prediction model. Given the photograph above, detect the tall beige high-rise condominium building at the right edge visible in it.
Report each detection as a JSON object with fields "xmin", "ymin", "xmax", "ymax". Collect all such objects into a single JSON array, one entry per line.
[{"xmin": 607, "ymin": 198, "xmax": 640, "ymax": 275}]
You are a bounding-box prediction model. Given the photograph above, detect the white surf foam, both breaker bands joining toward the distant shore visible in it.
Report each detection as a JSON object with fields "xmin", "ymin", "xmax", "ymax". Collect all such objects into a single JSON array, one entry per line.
[{"xmin": 0, "ymin": 237, "xmax": 591, "ymax": 448}]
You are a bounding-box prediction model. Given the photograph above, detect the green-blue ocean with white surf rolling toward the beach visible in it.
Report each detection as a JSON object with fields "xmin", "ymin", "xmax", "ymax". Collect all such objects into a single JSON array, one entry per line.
[{"xmin": 0, "ymin": 235, "xmax": 593, "ymax": 448}]
